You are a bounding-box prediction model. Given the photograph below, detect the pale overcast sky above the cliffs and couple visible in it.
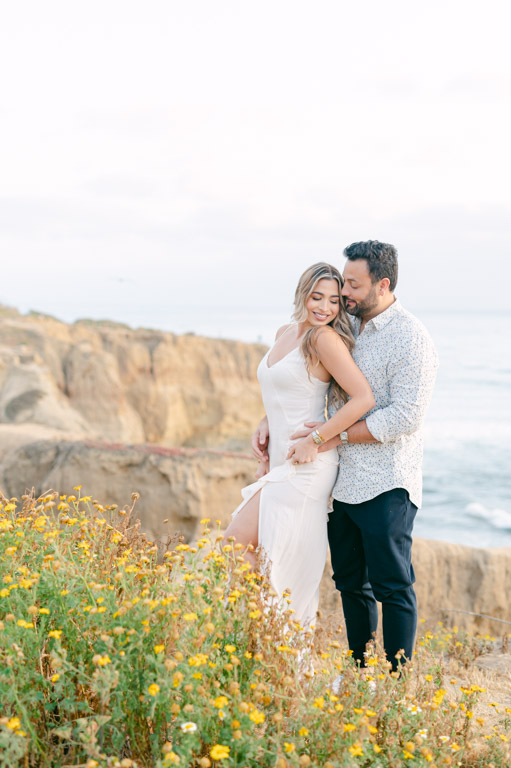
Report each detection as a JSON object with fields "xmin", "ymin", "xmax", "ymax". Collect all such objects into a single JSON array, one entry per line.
[{"xmin": 0, "ymin": 0, "xmax": 511, "ymax": 338}]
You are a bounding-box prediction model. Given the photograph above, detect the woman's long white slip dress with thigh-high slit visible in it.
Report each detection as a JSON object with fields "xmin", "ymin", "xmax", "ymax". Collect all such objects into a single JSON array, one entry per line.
[{"xmin": 233, "ymin": 340, "xmax": 338, "ymax": 629}]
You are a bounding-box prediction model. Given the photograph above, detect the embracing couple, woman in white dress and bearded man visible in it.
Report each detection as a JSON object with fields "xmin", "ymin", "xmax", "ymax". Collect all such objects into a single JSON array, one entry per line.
[{"xmin": 226, "ymin": 241, "xmax": 438, "ymax": 669}]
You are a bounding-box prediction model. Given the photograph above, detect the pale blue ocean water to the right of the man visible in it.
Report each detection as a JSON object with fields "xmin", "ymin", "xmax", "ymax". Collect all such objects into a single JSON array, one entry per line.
[{"xmin": 415, "ymin": 312, "xmax": 511, "ymax": 547}]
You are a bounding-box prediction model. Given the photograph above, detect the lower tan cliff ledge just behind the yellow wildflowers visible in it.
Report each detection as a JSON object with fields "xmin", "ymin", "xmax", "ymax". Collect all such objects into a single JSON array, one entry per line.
[{"xmin": 0, "ymin": 440, "xmax": 255, "ymax": 541}]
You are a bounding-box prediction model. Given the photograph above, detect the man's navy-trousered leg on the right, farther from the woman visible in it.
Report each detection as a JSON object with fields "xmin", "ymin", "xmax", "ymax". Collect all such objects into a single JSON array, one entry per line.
[{"xmin": 357, "ymin": 488, "xmax": 417, "ymax": 669}]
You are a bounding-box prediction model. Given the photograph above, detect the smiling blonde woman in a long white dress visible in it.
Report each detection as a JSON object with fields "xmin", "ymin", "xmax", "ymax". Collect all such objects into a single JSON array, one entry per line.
[{"xmin": 226, "ymin": 262, "xmax": 374, "ymax": 627}]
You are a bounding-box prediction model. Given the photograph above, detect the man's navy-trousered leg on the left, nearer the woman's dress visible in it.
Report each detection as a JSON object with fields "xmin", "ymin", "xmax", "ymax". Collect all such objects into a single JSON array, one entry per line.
[{"xmin": 328, "ymin": 500, "xmax": 378, "ymax": 666}]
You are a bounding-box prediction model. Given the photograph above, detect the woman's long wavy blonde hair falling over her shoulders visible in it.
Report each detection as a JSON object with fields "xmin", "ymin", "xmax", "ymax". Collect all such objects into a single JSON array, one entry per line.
[{"xmin": 293, "ymin": 261, "xmax": 355, "ymax": 404}]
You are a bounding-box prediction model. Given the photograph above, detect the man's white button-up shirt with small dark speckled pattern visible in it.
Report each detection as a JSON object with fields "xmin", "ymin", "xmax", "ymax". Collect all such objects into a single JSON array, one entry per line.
[{"xmin": 329, "ymin": 300, "xmax": 438, "ymax": 507}]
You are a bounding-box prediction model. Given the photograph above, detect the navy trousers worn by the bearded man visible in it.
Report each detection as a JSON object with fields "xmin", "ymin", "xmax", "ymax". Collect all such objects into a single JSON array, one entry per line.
[{"xmin": 328, "ymin": 488, "xmax": 417, "ymax": 670}]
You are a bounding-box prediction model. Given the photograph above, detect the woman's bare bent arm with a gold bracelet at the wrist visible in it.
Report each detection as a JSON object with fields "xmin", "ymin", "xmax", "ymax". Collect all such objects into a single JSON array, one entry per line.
[{"xmin": 288, "ymin": 328, "xmax": 375, "ymax": 464}]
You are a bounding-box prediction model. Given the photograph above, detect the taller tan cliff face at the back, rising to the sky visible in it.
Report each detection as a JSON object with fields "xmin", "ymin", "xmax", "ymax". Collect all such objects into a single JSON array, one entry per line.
[{"xmin": 0, "ymin": 308, "xmax": 265, "ymax": 449}]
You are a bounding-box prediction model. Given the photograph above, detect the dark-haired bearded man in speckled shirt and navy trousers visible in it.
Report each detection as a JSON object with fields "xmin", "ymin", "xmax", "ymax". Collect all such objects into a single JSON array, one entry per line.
[{"xmin": 293, "ymin": 240, "xmax": 438, "ymax": 670}]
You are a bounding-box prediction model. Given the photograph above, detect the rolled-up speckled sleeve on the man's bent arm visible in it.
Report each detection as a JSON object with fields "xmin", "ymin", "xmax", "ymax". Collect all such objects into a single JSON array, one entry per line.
[{"xmin": 366, "ymin": 332, "xmax": 438, "ymax": 443}]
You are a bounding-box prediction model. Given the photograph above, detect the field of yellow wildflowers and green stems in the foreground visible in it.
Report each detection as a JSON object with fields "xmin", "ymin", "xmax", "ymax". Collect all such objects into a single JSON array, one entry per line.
[{"xmin": 0, "ymin": 488, "xmax": 511, "ymax": 768}]
